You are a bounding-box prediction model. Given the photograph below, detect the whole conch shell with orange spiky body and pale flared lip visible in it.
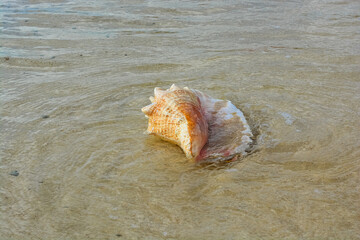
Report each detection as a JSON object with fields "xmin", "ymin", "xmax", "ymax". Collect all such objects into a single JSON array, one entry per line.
[{"xmin": 141, "ymin": 84, "xmax": 252, "ymax": 161}]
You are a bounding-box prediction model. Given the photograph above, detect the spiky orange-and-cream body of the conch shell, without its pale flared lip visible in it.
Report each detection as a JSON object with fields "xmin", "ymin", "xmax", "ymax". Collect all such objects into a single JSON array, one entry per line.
[{"xmin": 142, "ymin": 85, "xmax": 208, "ymax": 159}]
